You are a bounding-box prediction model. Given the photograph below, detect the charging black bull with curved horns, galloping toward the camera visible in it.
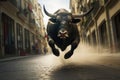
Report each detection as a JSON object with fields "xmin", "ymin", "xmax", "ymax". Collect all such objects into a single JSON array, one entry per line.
[{"xmin": 43, "ymin": 6, "xmax": 93, "ymax": 59}]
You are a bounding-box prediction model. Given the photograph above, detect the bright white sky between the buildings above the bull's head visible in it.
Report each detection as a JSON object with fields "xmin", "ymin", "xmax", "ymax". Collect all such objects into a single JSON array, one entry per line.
[{"xmin": 38, "ymin": 0, "xmax": 70, "ymax": 27}]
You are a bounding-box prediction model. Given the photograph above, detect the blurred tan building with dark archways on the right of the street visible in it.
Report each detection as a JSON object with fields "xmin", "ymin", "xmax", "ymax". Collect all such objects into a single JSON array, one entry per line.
[{"xmin": 70, "ymin": 0, "xmax": 120, "ymax": 52}]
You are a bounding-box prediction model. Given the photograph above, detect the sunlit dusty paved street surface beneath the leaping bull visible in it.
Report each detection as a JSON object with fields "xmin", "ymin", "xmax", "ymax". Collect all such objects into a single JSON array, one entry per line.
[{"xmin": 0, "ymin": 45, "xmax": 120, "ymax": 80}]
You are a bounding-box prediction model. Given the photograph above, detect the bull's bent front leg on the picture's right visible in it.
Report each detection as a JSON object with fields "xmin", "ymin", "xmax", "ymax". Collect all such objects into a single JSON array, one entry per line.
[{"xmin": 64, "ymin": 38, "xmax": 80, "ymax": 59}]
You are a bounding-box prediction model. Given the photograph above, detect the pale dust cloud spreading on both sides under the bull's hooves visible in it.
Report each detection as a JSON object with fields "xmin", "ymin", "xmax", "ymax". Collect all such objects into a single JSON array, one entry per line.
[{"xmin": 42, "ymin": 44, "xmax": 113, "ymax": 67}]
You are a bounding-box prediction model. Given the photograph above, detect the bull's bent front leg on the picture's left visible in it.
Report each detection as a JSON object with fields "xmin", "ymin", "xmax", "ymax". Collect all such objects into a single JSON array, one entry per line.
[{"xmin": 48, "ymin": 37, "xmax": 59, "ymax": 56}]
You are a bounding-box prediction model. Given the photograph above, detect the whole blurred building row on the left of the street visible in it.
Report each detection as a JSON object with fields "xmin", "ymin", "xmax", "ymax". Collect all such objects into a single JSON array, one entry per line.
[{"xmin": 0, "ymin": 0, "xmax": 47, "ymax": 56}]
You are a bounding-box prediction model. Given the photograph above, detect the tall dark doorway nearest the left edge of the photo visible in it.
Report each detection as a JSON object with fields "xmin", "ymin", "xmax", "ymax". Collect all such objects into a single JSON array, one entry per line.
[{"xmin": 1, "ymin": 13, "xmax": 15, "ymax": 55}]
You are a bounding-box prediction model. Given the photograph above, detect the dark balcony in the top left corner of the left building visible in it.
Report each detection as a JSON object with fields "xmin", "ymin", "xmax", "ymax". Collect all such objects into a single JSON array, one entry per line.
[{"xmin": 0, "ymin": 0, "xmax": 19, "ymax": 12}]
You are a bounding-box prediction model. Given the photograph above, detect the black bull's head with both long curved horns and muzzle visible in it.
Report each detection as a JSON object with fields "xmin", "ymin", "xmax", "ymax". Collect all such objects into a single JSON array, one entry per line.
[{"xmin": 43, "ymin": 6, "xmax": 93, "ymax": 39}]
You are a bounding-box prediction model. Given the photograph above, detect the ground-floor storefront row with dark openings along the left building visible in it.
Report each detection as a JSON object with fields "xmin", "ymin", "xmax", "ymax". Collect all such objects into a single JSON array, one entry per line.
[{"xmin": 0, "ymin": 10, "xmax": 42, "ymax": 56}]
